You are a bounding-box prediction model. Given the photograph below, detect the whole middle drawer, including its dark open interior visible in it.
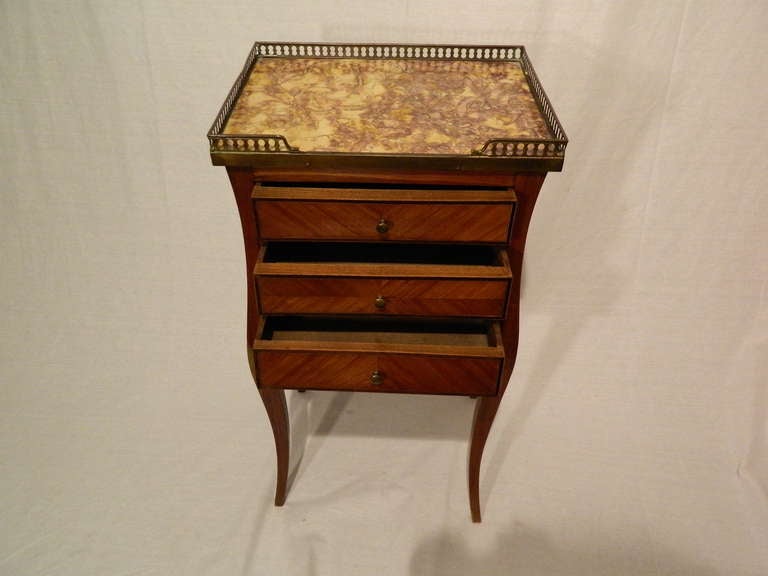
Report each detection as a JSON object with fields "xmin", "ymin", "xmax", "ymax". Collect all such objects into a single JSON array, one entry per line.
[{"xmin": 254, "ymin": 242, "xmax": 512, "ymax": 318}]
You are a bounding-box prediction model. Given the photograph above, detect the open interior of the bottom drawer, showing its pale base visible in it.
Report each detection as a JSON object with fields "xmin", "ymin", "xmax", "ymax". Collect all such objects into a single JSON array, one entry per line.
[{"xmin": 261, "ymin": 316, "xmax": 499, "ymax": 348}]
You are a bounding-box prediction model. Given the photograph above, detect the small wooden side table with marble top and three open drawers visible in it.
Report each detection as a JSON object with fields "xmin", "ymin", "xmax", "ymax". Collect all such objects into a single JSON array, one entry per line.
[{"xmin": 208, "ymin": 42, "xmax": 568, "ymax": 522}]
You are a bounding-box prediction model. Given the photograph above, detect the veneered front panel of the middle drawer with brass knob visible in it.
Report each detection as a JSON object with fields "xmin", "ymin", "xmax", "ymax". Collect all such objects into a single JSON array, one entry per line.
[{"xmin": 257, "ymin": 276, "xmax": 509, "ymax": 318}]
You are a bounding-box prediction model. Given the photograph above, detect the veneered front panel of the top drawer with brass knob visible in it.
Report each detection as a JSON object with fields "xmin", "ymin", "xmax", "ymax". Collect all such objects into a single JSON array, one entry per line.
[{"xmin": 255, "ymin": 200, "xmax": 513, "ymax": 243}]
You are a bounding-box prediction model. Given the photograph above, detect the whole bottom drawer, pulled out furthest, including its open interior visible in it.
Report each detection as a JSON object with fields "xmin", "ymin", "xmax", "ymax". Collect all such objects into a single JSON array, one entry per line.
[{"xmin": 253, "ymin": 317, "xmax": 504, "ymax": 396}]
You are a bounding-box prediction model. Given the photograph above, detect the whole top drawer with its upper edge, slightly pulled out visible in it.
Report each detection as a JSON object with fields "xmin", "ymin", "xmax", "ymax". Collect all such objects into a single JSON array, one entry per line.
[{"xmin": 253, "ymin": 184, "xmax": 516, "ymax": 243}]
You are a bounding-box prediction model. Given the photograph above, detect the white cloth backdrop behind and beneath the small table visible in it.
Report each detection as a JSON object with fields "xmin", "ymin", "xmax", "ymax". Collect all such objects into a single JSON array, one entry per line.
[{"xmin": 0, "ymin": 0, "xmax": 768, "ymax": 576}]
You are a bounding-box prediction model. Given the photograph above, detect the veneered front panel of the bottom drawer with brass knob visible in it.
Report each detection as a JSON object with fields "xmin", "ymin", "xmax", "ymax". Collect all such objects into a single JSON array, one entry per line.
[{"xmin": 256, "ymin": 350, "xmax": 502, "ymax": 396}]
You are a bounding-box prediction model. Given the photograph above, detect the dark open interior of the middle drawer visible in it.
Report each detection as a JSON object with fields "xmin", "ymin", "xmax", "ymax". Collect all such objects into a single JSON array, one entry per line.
[{"xmin": 263, "ymin": 242, "xmax": 503, "ymax": 266}]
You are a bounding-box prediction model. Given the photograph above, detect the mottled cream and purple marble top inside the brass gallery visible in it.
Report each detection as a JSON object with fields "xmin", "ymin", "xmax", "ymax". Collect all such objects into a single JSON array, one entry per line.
[{"xmin": 223, "ymin": 58, "xmax": 551, "ymax": 155}]
